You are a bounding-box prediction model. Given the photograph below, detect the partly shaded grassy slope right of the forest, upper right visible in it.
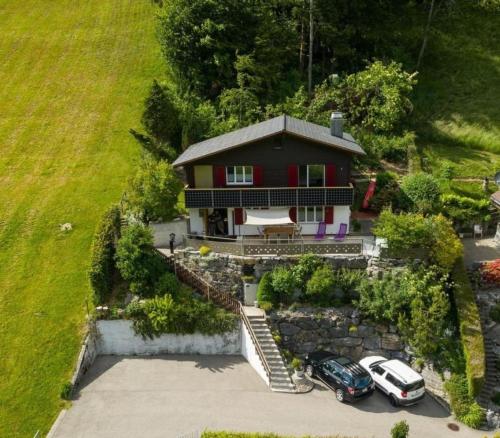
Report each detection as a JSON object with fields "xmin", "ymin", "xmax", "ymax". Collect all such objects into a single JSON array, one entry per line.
[{"xmin": 416, "ymin": 2, "xmax": 500, "ymax": 187}]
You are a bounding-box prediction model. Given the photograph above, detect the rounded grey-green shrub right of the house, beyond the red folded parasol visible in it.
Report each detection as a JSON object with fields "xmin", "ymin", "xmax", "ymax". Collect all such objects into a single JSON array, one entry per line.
[{"xmin": 401, "ymin": 173, "xmax": 441, "ymax": 213}]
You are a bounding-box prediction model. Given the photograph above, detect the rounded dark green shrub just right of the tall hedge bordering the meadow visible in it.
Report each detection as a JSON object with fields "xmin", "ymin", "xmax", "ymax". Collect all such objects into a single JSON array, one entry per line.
[{"xmin": 116, "ymin": 224, "xmax": 167, "ymax": 297}]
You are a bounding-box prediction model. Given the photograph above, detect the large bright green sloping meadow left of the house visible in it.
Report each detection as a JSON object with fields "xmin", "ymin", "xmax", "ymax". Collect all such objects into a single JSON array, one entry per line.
[{"xmin": 0, "ymin": 0, "xmax": 161, "ymax": 437}]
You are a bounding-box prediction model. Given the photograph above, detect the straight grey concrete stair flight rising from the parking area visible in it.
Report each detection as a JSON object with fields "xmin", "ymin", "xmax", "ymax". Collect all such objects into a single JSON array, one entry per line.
[{"xmin": 247, "ymin": 315, "xmax": 295, "ymax": 392}]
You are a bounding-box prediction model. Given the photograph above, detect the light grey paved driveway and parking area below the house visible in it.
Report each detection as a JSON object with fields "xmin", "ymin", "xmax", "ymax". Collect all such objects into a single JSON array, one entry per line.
[{"xmin": 51, "ymin": 356, "xmax": 485, "ymax": 438}]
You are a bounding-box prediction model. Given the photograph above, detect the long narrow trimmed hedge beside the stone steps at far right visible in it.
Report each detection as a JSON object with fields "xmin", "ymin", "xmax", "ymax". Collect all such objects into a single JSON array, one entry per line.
[{"xmin": 451, "ymin": 258, "xmax": 486, "ymax": 397}]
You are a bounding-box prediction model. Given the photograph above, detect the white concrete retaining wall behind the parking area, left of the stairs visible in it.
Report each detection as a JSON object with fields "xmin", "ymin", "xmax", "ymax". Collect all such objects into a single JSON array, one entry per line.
[{"xmin": 97, "ymin": 320, "xmax": 241, "ymax": 355}]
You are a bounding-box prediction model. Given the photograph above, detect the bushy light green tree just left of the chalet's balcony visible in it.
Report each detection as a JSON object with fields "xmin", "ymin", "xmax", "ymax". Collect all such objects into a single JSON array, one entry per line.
[{"xmin": 128, "ymin": 159, "xmax": 182, "ymax": 223}]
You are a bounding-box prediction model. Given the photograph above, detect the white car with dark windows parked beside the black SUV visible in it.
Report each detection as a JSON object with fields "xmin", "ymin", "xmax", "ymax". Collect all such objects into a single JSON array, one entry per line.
[{"xmin": 359, "ymin": 356, "xmax": 425, "ymax": 406}]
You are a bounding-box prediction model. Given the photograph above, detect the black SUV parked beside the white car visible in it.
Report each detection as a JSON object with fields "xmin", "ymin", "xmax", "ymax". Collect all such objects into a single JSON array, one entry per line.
[{"xmin": 304, "ymin": 351, "xmax": 375, "ymax": 402}]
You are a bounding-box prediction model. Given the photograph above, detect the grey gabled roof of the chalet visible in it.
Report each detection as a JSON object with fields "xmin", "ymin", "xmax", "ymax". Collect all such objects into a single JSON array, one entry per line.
[{"xmin": 174, "ymin": 115, "xmax": 365, "ymax": 166}]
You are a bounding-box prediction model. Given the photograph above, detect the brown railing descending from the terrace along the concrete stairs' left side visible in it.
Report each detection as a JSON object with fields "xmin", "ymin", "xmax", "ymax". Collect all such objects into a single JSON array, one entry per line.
[{"xmin": 157, "ymin": 250, "xmax": 271, "ymax": 383}]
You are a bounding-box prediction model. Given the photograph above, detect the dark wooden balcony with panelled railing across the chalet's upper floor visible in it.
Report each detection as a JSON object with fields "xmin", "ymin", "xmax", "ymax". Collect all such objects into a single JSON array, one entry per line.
[{"xmin": 185, "ymin": 184, "xmax": 354, "ymax": 208}]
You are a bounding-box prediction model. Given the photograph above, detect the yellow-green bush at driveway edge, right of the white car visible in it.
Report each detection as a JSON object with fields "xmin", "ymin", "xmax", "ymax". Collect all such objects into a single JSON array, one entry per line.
[{"xmin": 445, "ymin": 374, "xmax": 484, "ymax": 429}]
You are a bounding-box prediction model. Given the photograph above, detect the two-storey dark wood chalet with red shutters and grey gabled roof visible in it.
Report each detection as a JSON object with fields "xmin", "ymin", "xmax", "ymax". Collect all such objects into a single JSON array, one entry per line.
[{"xmin": 174, "ymin": 113, "xmax": 365, "ymax": 240}]
